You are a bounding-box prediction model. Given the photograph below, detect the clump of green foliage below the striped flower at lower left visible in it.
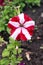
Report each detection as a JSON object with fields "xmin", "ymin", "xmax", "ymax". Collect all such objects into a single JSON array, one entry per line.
[{"xmin": 0, "ymin": 38, "xmax": 22, "ymax": 65}]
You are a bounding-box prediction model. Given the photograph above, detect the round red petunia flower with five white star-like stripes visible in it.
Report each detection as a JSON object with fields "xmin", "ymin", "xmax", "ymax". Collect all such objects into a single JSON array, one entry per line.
[{"xmin": 8, "ymin": 13, "xmax": 35, "ymax": 41}]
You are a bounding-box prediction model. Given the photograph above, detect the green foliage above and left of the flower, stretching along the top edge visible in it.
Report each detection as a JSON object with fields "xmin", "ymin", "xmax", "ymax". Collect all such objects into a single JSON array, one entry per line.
[{"xmin": 0, "ymin": 0, "xmax": 40, "ymax": 33}]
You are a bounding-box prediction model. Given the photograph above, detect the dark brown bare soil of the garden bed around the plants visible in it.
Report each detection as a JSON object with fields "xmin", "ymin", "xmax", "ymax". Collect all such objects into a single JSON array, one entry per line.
[{"xmin": 0, "ymin": 1, "xmax": 43, "ymax": 65}]
